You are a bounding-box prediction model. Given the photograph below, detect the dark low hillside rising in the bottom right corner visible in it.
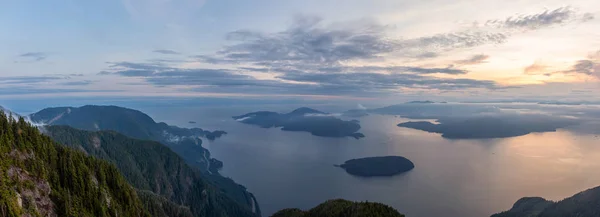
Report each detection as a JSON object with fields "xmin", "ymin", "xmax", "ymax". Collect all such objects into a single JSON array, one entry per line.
[{"xmin": 492, "ymin": 187, "xmax": 600, "ymax": 217}]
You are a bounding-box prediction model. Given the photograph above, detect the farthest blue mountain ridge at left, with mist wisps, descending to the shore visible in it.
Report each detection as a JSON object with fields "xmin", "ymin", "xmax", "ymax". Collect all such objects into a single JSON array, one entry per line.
[{"xmin": 29, "ymin": 106, "xmax": 260, "ymax": 214}]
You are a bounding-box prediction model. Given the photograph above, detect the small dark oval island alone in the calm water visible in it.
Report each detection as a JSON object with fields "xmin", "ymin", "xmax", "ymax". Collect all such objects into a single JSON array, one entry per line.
[{"xmin": 336, "ymin": 156, "xmax": 415, "ymax": 177}]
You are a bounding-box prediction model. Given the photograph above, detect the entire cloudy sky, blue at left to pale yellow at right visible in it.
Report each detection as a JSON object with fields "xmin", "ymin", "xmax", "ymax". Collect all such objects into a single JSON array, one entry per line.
[{"xmin": 0, "ymin": 0, "xmax": 600, "ymax": 101}]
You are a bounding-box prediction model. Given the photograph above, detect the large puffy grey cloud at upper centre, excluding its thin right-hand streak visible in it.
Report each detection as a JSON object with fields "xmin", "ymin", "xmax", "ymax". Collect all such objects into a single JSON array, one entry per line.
[{"xmin": 214, "ymin": 16, "xmax": 399, "ymax": 64}]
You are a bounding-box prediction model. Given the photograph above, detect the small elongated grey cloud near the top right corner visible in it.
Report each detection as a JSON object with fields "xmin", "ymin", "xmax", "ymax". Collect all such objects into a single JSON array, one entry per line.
[{"xmin": 486, "ymin": 6, "xmax": 594, "ymax": 30}]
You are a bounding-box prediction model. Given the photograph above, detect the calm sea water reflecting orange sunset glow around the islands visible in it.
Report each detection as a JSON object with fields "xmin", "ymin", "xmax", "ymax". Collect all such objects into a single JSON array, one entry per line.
[{"xmin": 142, "ymin": 106, "xmax": 600, "ymax": 217}]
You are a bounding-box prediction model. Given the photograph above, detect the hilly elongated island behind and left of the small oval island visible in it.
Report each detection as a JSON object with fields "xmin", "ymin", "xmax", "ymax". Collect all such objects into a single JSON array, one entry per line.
[{"xmin": 233, "ymin": 107, "xmax": 365, "ymax": 139}]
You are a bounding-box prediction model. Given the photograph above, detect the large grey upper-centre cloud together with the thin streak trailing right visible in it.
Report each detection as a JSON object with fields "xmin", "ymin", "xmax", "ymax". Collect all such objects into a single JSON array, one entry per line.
[{"xmin": 198, "ymin": 16, "xmax": 508, "ymax": 65}]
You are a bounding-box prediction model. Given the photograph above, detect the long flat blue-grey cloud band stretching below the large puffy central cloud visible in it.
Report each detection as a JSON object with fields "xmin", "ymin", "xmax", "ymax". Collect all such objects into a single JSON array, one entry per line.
[{"xmin": 102, "ymin": 60, "xmax": 501, "ymax": 96}]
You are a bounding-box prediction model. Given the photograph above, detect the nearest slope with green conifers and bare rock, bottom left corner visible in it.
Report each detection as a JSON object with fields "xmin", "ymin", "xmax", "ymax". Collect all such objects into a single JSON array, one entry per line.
[{"xmin": 0, "ymin": 113, "xmax": 149, "ymax": 217}]
